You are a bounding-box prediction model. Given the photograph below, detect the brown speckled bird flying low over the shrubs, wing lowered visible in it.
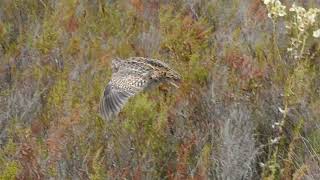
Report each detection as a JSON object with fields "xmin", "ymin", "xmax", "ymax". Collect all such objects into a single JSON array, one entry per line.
[{"xmin": 100, "ymin": 57, "xmax": 181, "ymax": 120}]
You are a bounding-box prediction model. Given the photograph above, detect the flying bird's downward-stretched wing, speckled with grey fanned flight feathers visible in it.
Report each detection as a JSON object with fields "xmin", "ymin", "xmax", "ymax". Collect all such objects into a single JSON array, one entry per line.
[{"xmin": 100, "ymin": 69, "xmax": 150, "ymax": 119}]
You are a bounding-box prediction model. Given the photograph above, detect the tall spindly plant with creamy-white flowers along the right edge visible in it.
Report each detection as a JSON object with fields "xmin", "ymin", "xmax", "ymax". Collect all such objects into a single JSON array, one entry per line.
[{"xmin": 260, "ymin": 0, "xmax": 320, "ymax": 179}]
